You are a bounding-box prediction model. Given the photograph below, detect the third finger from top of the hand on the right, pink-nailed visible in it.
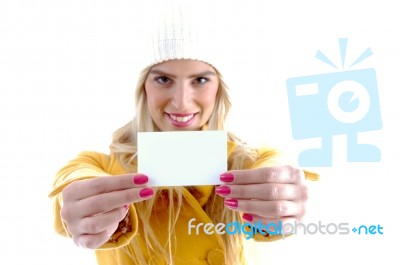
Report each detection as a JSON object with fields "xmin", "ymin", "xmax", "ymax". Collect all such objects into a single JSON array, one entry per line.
[{"xmin": 225, "ymin": 199, "xmax": 304, "ymax": 219}]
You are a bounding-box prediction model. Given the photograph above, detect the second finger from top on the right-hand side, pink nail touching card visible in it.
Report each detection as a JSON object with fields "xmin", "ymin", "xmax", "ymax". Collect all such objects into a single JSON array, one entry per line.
[{"xmin": 215, "ymin": 183, "xmax": 307, "ymax": 201}]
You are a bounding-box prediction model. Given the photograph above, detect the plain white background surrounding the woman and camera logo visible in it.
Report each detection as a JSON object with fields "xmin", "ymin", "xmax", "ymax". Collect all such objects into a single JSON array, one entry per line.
[{"xmin": 0, "ymin": 0, "xmax": 400, "ymax": 264}]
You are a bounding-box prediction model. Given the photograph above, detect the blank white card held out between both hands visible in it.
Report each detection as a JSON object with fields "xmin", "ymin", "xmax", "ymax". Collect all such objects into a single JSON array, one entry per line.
[{"xmin": 138, "ymin": 131, "xmax": 228, "ymax": 186}]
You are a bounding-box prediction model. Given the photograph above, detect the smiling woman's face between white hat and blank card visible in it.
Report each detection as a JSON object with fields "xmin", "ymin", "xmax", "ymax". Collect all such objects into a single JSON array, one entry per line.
[{"xmin": 145, "ymin": 60, "xmax": 219, "ymax": 131}]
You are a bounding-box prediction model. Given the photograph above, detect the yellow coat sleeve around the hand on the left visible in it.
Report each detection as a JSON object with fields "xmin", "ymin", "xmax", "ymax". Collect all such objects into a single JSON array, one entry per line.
[{"xmin": 49, "ymin": 152, "xmax": 138, "ymax": 249}]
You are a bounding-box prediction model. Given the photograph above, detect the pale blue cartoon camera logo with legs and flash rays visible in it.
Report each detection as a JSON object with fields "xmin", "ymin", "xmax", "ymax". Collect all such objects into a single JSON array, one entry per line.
[{"xmin": 286, "ymin": 39, "xmax": 382, "ymax": 167}]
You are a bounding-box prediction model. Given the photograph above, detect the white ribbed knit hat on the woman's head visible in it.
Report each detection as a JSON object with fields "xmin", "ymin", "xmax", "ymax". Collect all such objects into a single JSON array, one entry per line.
[{"xmin": 145, "ymin": 0, "xmax": 222, "ymax": 71}]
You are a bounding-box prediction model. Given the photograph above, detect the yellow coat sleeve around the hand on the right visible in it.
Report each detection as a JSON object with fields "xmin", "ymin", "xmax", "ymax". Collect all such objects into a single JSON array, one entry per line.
[{"xmin": 251, "ymin": 148, "xmax": 319, "ymax": 242}]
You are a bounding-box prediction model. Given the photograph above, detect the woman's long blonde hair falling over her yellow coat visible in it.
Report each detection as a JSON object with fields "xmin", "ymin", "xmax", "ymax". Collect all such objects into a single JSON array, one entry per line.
[{"xmin": 110, "ymin": 63, "xmax": 264, "ymax": 264}]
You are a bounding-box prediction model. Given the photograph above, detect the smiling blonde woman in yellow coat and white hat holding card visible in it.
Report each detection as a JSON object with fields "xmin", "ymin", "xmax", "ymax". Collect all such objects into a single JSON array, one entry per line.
[{"xmin": 50, "ymin": 3, "xmax": 316, "ymax": 265}]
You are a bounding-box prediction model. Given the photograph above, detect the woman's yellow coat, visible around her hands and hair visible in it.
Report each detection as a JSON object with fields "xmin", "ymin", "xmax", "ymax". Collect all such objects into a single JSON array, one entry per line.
[{"xmin": 49, "ymin": 139, "xmax": 317, "ymax": 265}]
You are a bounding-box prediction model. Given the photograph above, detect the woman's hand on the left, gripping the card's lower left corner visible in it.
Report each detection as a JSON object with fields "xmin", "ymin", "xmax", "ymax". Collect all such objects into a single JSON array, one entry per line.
[{"xmin": 60, "ymin": 174, "xmax": 154, "ymax": 249}]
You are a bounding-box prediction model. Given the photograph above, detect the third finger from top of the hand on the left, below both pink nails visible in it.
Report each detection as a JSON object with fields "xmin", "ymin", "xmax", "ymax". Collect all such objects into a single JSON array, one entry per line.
[{"xmin": 75, "ymin": 206, "xmax": 128, "ymax": 234}]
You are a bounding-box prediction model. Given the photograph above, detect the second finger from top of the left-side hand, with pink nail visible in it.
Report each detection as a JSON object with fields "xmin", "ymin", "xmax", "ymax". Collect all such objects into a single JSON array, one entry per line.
[{"xmin": 75, "ymin": 187, "xmax": 154, "ymax": 218}]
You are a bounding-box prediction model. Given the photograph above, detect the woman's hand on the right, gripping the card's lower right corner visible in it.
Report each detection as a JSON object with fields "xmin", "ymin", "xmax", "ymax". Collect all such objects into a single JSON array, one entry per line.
[{"xmin": 216, "ymin": 166, "xmax": 307, "ymax": 224}]
